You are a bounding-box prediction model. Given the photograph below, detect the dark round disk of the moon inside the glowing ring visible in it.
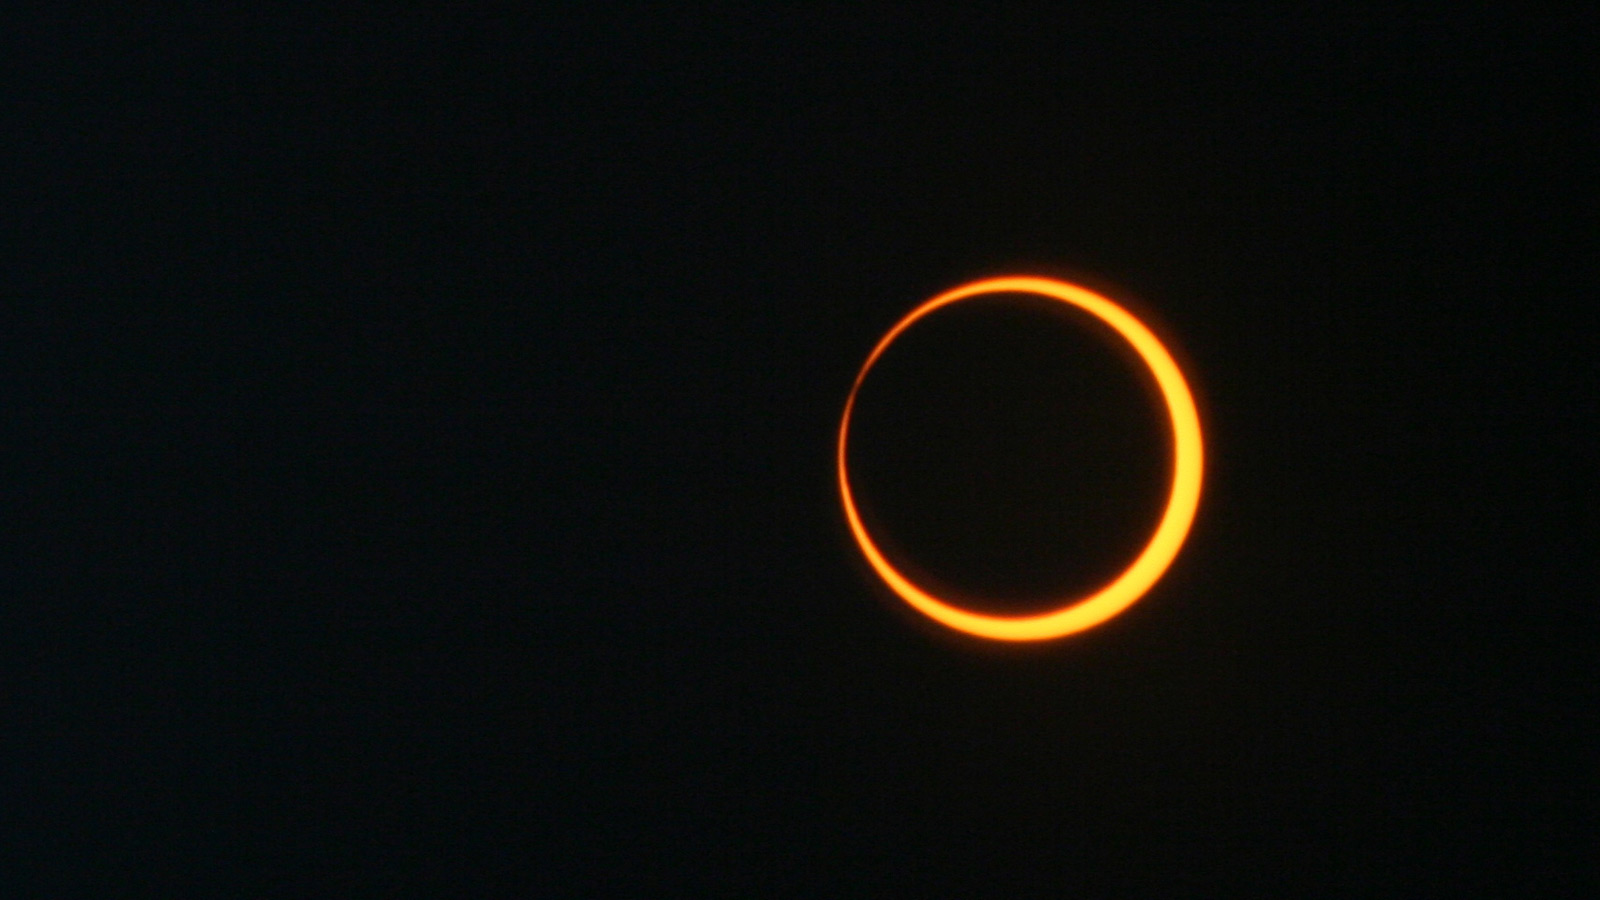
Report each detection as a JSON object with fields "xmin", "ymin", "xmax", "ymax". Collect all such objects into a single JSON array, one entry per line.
[{"xmin": 848, "ymin": 293, "xmax": 1173, "ymax": 615}]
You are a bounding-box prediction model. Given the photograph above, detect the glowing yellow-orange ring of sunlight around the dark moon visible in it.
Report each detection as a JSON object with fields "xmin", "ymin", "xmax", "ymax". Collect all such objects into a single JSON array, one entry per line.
[{"xmin": 838, "ymin": 275, "xmax": 1205, "ymax": 641}]
